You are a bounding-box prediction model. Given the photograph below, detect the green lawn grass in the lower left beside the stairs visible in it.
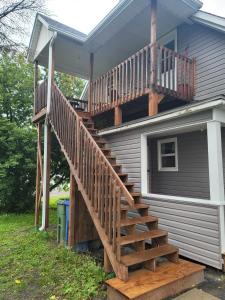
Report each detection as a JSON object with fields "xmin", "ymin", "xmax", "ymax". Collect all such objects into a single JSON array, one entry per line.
[{"xmin": 0, "ymin": 210, "xmax": 105, "ymax": 300}]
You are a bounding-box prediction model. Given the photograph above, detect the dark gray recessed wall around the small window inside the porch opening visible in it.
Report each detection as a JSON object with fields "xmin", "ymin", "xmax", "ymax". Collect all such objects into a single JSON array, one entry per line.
[{"xmin": 148, "ymin": 130, "xmax": 210, "ymax": 199}]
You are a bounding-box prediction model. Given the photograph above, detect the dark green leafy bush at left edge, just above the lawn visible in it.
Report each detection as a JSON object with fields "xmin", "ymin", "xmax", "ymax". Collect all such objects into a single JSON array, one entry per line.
[{"xmin": 0, "ymin": 118, "xmax": 36, "ymax": 212}]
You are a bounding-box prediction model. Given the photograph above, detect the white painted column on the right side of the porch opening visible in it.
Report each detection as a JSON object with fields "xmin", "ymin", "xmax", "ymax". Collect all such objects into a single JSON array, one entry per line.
[{"xmin": 207, "ymin": 121, "xmax": 225, "ymax": 253}]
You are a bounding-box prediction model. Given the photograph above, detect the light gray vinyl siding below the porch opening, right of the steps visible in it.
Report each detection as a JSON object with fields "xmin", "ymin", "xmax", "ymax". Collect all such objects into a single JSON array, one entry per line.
[{"xmin": 142, "ymin": 198, "xmax": 222, "ymax": 269}]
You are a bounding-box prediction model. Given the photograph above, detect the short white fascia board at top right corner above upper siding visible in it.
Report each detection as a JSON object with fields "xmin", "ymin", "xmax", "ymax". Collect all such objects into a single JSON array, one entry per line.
[{"xmin": 191, "ymin": 10, "xmax": 225, "ymax": 32}]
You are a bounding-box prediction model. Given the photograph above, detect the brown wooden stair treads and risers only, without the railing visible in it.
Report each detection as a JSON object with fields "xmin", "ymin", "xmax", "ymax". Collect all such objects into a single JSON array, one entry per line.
[{"xmin": 77, "ymin": 112, "xmax": 179, "ymax": 271}]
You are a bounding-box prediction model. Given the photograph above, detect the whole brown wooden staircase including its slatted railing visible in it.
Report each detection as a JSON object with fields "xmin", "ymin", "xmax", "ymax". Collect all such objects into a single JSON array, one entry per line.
[{"xmin": 48, "ymin": 83, "xmax": 181, "ymax": 281}]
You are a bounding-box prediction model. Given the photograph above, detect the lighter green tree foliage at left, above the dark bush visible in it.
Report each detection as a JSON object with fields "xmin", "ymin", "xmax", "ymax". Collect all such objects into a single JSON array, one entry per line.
[{"xmin": 0, "ymin": 53, "xmax": 33, "ymax": 126}]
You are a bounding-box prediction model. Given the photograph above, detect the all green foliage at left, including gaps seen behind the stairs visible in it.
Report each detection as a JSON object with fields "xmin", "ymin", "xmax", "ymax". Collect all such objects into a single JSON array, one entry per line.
[{"xmin": 0, "ymin": 53, "xmax": 84, "ymax": 212}]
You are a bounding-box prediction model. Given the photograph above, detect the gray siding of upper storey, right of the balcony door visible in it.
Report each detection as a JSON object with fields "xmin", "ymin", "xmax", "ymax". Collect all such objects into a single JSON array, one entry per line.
[{"xmin": 178, "ymin": 24, "xmax": 225, "ymax": 100}]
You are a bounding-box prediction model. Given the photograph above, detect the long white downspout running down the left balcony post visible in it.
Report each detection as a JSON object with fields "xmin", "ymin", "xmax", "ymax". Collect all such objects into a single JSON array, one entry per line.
[{"xmin": 39, "ymin": 32, "xmax": 57, "ymax": 231}]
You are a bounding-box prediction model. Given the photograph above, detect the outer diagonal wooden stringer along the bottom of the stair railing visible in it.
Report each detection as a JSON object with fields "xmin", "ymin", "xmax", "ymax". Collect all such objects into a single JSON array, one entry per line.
[{"xmin": 50, "ymin": 120, "xmax": 128, "ymax": 281}]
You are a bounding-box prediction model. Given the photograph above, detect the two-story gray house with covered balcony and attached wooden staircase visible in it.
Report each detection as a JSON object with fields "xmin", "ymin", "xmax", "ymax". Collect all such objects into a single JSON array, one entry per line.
[{"xmin": 28, "ymin": 0, "xmax": 225, "ymax": 299}]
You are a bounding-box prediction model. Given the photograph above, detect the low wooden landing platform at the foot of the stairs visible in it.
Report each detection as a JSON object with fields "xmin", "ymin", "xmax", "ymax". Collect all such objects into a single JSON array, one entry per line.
[{"xmin": 106, "ymin": 259, "xmax": 205, "ymax": 300}]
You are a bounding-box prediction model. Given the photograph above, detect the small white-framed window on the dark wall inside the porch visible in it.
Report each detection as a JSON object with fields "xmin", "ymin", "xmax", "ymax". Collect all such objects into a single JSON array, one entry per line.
[{"xmin": 158, "ymin": 138, "xmax": 178, "ymax": 171}]
